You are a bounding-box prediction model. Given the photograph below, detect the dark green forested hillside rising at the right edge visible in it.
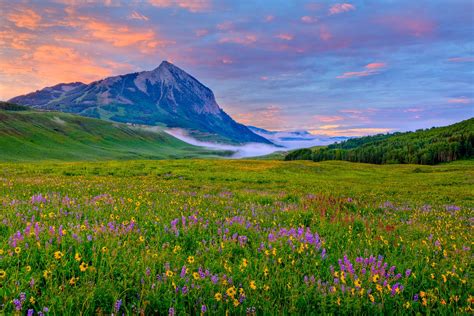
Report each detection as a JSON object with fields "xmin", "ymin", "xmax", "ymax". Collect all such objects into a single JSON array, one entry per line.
[{"xmin": 285, "ymin": 118, "xmax": 474, "ymax": 165}]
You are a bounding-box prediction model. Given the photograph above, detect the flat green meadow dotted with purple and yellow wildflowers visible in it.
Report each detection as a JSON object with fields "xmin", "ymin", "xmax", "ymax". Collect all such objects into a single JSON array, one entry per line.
[{"xmin": 0, "ymin": 160, "xmax": 474, "ymax": 315}]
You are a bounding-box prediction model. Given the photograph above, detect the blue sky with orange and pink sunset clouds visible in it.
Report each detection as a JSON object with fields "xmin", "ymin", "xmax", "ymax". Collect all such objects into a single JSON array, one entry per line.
[{"xmin": 0, "ymin": 0, "xmax": 474, "ymax": 136}]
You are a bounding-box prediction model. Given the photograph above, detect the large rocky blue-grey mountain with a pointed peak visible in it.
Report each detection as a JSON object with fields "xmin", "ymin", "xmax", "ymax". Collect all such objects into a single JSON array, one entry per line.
[{"xmin": 9, "ymin": 61, "xmax": 270, "ymax": 143}]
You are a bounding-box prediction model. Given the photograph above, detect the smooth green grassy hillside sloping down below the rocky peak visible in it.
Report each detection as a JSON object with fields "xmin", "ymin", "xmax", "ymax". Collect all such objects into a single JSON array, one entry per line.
[{"xmin": 0, "ymin": 103, "xmax": 230, "ymax": 161}]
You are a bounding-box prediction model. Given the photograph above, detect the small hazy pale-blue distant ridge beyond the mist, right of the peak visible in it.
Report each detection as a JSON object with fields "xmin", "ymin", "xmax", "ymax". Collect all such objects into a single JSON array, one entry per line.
[{"xmin": 247, "ymin": 126, "xmax": 349, "ymax": 149}]
